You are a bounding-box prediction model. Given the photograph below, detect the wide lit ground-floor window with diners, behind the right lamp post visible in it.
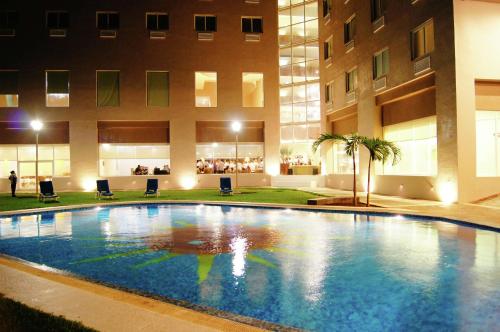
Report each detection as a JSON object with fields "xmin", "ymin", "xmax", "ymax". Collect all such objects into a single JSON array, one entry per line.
[{"xmin": 196, "ymin": 142, "xmax": 264, "ymax": 174}]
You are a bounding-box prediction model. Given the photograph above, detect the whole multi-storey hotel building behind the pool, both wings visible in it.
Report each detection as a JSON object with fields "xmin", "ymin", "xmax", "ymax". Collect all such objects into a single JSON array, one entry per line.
[{"xmin": 0, "ymin": 0, "xmax": 500, "ymax": 202}]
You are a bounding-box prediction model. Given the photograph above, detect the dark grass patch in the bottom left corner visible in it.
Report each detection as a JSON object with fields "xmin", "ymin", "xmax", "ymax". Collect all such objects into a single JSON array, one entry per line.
[{"xmin": 0, "ymin": 294, "xmax": 95, "ymax": 332}]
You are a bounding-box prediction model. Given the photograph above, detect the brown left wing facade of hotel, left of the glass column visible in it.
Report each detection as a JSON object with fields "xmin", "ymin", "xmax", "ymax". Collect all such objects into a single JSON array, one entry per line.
[{"xmin": 0, "ymin": 0, "xmax": 280, "ymax": 191}]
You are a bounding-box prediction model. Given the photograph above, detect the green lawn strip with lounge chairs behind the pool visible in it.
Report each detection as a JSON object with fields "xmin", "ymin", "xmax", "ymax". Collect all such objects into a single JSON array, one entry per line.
[{"xmin": 0, "ymin": 188, "xmax": 318, "ymax": 211}]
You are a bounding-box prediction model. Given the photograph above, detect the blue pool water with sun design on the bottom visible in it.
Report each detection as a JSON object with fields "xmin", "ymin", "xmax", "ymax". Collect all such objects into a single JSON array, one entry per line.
[{"xmin": 0, "ymin": 204, "xmax": 500, "ymax": 331}]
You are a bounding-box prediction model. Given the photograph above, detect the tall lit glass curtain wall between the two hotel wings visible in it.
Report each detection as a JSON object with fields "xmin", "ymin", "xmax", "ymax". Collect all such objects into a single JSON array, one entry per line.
[{"xmin": 278, "ymin": 0, "xmax": 321, "ymax": 174}]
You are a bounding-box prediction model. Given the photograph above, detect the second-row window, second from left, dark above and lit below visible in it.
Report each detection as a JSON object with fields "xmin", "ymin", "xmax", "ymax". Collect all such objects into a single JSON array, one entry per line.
[{"xmin": 45, "ymin": 70, "xmax": 69, "ymax": 107}]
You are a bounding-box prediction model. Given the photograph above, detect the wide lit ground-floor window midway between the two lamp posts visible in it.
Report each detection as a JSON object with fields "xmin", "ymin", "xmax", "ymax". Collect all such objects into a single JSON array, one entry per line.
[{"xmin": 99, "ymin": 143, "xmax": 170, "ymax": 176}]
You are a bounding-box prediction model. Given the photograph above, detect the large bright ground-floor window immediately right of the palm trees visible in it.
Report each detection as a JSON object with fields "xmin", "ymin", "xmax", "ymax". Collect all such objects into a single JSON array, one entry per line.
[{"xmin": 383, "ymin": 116, "xmax": 437, "ymax": 176}]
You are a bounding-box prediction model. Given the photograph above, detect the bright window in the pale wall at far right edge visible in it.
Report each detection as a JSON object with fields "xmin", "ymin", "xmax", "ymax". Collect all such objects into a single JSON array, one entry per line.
[{"xmin": 476, "ymin": 111, "xmax": 500, "ymax": 177}]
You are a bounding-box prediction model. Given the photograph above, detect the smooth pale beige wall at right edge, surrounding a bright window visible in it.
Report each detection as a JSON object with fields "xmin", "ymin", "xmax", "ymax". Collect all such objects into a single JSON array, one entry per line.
[{"xmin": 454, "ymin": 0, "xmax": 500, "ymax": 202}]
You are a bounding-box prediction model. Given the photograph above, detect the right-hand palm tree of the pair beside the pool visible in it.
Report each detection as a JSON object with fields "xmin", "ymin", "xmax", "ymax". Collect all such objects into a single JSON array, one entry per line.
[{"xmin": 361, "ymin": 137, "xmax": 401, "ymax": 206}]
